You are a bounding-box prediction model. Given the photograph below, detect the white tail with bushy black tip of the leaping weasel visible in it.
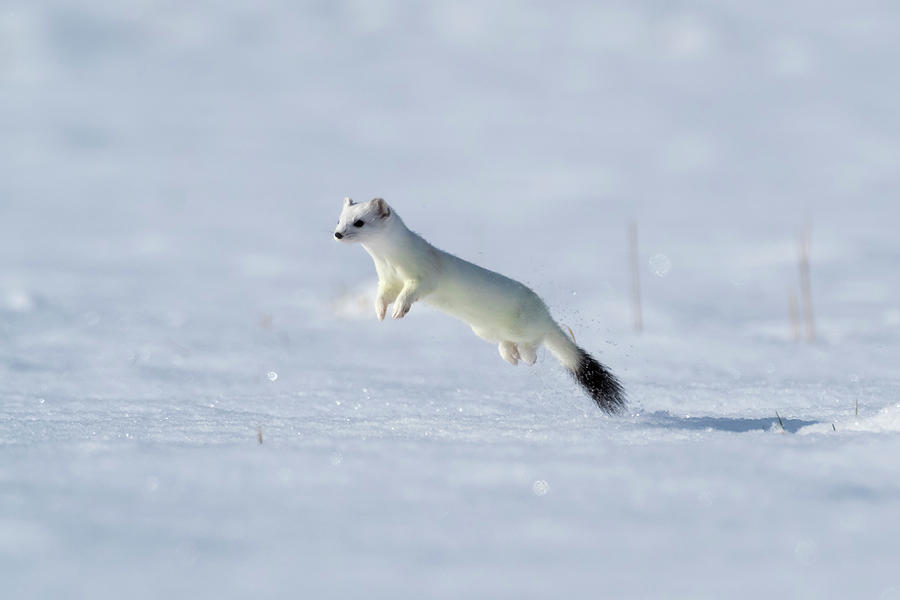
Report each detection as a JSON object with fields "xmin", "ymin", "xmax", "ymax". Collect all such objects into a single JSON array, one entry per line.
[{"xmin": 544, "ymin": 326, "xmax": 625, "ymax": 415}]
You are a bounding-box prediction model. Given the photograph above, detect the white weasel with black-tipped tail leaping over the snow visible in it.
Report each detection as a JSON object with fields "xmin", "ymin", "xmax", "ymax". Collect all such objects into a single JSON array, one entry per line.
[{"xmin": 334, "ymin": 198, "xmax": 625, "ymax": 414}]
